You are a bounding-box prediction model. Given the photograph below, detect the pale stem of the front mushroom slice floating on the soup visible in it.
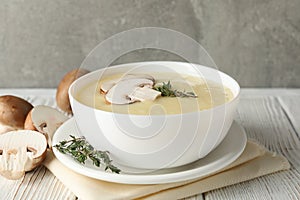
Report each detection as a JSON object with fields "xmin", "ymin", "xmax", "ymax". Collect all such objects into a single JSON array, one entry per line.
[{"xmin": 128, "ymin": 86, "xmax": 161, "ymax": 101}]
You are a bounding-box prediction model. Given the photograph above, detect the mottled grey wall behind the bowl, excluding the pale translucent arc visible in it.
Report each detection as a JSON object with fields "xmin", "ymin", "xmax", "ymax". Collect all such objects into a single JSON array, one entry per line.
[{"xmin": 0, "ymin": 0, "xmax": 300, "ymax": 88}]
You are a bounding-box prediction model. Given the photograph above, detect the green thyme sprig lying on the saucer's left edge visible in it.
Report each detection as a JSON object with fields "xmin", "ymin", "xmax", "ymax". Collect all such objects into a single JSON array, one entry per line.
[{"xmin": 54, "ymin": 135, "xmax": 121, "ymax": 174}]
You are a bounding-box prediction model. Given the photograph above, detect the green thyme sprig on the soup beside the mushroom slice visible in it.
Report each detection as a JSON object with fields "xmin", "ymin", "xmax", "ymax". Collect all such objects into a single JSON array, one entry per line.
[{"xmin": 153, "ymin": 81, "xmax": 197, "ymax": 98}]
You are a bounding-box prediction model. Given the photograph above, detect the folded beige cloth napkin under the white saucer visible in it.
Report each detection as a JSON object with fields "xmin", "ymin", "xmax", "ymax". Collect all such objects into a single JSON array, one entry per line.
[{"xmin": 44, "ymin": 141, "xmax": 290, "ymax": 200}]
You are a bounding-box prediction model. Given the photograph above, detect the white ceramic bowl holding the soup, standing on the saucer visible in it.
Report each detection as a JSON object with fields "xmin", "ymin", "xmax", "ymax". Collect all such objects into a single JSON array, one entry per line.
[{"xmin": 69, "ymin": 62, "xmax": 240, "ymax": 169}]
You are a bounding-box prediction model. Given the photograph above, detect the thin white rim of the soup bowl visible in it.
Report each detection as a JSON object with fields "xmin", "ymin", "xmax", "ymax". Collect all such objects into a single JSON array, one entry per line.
[{"xmin": 68, "ymin": 61, "xmax": 241, "ymax": 117}]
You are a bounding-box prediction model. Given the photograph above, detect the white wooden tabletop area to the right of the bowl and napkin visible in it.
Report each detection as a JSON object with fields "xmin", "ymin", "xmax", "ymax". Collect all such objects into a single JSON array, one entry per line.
[{"xmin": 204, "ymin": 90, "xmax": 300, "ymax": 199}]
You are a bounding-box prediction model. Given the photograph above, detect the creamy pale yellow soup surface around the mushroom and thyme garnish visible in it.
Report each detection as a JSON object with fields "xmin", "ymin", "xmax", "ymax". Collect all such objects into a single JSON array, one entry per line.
[{"xmin": 75, "ymin": 73, "xmax": 234, "ymax": 115}]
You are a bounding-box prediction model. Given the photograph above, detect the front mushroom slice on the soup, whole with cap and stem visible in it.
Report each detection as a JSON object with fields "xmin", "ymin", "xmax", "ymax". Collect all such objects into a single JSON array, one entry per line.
[{"xmin": 105, "ymin": 78, "xmax": 160, "ymax": 104}]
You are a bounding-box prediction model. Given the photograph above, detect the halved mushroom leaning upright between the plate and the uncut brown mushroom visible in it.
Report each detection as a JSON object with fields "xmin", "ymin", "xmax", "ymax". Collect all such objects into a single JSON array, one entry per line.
[{"xmin": 24, "ymin": 105, "xmax": 68, "ymax": 147}]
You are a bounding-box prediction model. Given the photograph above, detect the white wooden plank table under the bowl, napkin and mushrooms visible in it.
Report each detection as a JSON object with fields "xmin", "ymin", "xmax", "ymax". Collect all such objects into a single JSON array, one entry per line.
[{"xmin": 0, "ymin": 89, "xmax": 300, "ymax": 200}]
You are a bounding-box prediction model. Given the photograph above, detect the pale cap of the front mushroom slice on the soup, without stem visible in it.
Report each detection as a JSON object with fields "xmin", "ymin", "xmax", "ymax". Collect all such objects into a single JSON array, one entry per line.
[{"xmin": 105, "ymin": 78, "xmax": 154, "ymax": 104}]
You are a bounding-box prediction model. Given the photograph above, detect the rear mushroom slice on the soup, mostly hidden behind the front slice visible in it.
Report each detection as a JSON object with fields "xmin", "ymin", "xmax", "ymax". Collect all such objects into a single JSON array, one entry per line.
[{"xmin": 100, "ymin": 74, "xmax": 155, "ymax": 94}]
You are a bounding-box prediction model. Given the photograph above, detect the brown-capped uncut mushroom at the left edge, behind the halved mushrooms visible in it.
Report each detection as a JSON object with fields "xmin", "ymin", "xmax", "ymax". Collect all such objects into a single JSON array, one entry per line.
[{"xmin": 0, "ymin": 95, "xmax": 33, "ymax": 134}]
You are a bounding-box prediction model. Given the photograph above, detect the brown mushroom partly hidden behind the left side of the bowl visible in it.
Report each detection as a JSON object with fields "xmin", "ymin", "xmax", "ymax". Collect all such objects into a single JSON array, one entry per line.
[{"xmin": 56, "ymin": 69, "xmax": 89, "ymax": 114}]
